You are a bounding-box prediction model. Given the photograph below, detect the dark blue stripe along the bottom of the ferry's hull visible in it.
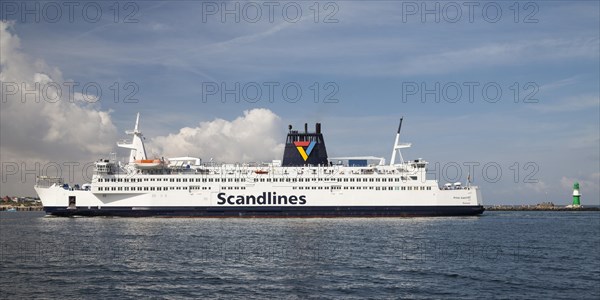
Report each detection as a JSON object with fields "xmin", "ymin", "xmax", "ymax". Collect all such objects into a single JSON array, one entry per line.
[{"xmin": 44, "ymin": 206, "xmax": 485, "ymax": 218}]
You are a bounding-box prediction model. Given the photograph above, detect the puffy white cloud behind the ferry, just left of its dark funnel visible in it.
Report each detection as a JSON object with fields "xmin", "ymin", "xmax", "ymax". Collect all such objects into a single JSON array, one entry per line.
[{"xmin": 148, "ymin": 109, "xmax": 285, "ymax": 163}]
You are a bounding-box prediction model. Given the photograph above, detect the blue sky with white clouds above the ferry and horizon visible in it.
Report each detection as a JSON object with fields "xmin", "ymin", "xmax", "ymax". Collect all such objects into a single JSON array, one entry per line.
[{"xmin": 0, "ymin": 1, "xmax": 600, "ymax": 206}]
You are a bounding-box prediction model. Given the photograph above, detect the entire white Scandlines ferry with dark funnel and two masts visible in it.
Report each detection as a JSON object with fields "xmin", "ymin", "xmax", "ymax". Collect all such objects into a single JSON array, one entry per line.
[{"xmin": 35, "ymin": 113, "xmax": 484, "ymax": 218}]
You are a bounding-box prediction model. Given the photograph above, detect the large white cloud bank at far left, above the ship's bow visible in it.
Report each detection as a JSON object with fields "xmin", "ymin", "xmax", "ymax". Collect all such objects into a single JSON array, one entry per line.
[{"xmin": 0, "ymin": 22, "xmax": 117, "ymax": 194}]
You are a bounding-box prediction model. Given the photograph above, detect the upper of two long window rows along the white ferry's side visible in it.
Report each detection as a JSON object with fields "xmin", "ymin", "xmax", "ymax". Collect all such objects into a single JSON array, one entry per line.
[{"xmin": 98, "ymin": 176, "xmax": 417, "ymax": 182}]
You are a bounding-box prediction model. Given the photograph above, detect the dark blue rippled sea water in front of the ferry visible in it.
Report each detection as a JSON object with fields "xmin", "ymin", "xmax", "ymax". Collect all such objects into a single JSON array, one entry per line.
[{"xmin": 0, "ymin": 211, "xmax": 600, "ymax": 299}]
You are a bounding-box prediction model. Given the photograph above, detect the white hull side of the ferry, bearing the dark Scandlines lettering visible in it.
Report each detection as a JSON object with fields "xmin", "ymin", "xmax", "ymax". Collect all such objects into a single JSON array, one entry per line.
[{"xmin": 36, "ymin": 167, "xmax": 481, "ymax": 217}]
